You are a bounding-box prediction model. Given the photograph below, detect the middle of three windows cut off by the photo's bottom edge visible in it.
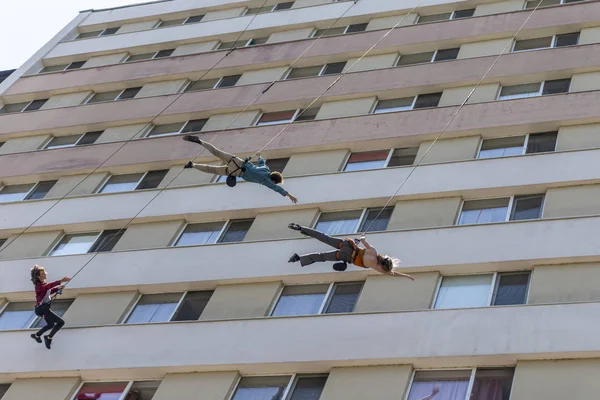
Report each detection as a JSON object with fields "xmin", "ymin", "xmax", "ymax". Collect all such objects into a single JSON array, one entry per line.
[{"xmin": 231, "ymin": 375, "xmax": 327, "ymax": 400}]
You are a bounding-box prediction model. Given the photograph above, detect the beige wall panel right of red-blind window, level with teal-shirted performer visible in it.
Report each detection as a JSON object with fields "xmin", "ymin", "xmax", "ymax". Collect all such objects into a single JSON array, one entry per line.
[{"xmin": 415, "ymin": 136, "xmax": 480, "ymax": 164}]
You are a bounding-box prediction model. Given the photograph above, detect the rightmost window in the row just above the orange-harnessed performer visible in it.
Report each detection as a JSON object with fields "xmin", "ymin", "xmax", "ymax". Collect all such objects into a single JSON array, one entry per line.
[{"xmin": 458, "ymin": 194, "xmax": 544, "ymax": 225}]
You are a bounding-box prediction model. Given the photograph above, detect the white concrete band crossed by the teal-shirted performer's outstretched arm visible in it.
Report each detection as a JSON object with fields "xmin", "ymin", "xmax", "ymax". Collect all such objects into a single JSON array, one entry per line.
[{"xmin": 0, "ymin": 150, "xmax": 600, "ymax": 231}]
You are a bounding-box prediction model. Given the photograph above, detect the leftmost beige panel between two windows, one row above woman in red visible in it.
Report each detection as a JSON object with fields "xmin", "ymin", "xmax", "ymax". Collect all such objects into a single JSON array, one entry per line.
[{"xmin": 113, "ymin": 220, "xmax": 185, "ymax": 251}]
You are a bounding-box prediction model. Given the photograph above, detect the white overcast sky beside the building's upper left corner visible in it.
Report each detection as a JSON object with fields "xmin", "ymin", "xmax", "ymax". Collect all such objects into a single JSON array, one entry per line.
[{"xmin": 0, "ymin": 0, "xmax": 144, "ymax": 71}]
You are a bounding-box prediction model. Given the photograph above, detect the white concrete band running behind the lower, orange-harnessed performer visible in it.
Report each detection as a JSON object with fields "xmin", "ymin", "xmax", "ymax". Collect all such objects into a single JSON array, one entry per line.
[{"xmin": 0, "ymin": 217, "xmax": 600, "ymax": 297}]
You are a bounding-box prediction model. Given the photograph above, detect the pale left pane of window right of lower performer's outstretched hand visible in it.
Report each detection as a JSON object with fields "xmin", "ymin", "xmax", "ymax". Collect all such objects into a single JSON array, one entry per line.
[{"xmin": 433, "ymin": 274, "xmax": 493, "ymax": 309}]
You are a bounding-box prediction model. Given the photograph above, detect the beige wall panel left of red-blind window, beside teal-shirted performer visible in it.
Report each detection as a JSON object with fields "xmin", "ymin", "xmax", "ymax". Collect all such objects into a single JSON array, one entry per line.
[{"xmin": 283, "ymin": 149, "xmax": 348, "ymax": 176}]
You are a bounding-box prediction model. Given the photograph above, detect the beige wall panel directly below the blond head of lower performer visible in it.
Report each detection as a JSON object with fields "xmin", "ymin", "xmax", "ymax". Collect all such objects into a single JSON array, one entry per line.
[{"xmin": 355, "ymin": 272, "xmax": 440, "ymax": 312}]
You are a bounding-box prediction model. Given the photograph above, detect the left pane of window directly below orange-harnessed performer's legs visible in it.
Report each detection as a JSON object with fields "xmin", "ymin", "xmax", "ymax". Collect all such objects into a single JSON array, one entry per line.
[{"xmin": 271, "ymin": 285, "xmax": 329, "ymax": 316}]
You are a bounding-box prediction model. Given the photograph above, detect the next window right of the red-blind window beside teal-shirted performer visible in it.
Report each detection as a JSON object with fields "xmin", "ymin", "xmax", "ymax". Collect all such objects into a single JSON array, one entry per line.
[{"xmin": 477, "ymin": 132, "xmax": 558, "ymax": 158}]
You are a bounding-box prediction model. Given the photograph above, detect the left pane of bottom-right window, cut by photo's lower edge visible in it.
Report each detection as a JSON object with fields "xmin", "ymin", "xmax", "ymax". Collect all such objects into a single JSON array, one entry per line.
[{"xmin": 407, "ymin": 370, "xmax": 471, "ymax": 400}]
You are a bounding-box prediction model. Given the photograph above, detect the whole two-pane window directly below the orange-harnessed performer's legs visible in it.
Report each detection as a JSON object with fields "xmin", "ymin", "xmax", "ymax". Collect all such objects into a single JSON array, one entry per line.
[{"xmin": 271, "ymin": 282, "xmax": 363, "ymax": 317}]
